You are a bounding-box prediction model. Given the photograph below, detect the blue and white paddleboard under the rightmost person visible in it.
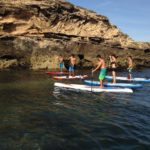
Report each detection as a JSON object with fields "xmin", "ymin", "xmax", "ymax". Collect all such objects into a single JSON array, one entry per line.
[{"xmin": 105, "ymin": 76, "xmax": 150, "ymax": 83}]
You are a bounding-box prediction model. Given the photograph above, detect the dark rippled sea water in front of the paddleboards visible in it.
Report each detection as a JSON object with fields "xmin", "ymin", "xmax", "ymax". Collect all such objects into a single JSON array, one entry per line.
[{"xmin": 0, "ymin": 69, "xmax": 150, "ymax": 150}]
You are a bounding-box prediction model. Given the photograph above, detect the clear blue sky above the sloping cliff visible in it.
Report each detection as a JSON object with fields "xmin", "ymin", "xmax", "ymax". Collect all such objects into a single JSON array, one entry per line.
[{"xmin": 68, "ymin": 0, "xmax": 150, "ymax": 42}]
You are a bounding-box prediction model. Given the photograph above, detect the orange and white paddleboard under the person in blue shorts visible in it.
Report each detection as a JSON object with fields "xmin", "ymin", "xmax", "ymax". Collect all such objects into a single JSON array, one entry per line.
[{"xmin": 53, "ymin": 75, "xmax": 88, "ymax": 80}]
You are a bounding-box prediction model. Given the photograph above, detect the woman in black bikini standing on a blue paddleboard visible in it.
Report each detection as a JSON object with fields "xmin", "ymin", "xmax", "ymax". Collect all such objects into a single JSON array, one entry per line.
[{"xmin": 109, "ymin": 54, "xmax": 117, "ymax": 84}]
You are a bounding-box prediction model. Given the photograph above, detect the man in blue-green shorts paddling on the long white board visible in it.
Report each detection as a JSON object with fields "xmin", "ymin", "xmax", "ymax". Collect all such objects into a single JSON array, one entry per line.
[{"xmin": 92, "ymin": 55, "xmax": 106, "ymax": 88}]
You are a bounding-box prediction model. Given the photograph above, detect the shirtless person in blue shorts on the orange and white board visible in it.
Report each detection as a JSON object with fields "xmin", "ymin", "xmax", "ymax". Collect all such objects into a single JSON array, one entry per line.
[{"xmin": 69, "ymin": 54, "xmax": 76, "ymax": 76}]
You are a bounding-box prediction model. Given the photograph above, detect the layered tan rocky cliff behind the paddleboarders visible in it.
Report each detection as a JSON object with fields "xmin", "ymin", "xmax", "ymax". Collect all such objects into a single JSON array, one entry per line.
[{"xmin": 0, "ymin": 0, "xmax": 150, "ymax": 69}]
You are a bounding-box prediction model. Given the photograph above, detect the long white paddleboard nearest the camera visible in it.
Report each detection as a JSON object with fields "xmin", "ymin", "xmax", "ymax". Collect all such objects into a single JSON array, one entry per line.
[{"xmin": 54, "ymin": 82, "xmax": 133, "ymax": 93}]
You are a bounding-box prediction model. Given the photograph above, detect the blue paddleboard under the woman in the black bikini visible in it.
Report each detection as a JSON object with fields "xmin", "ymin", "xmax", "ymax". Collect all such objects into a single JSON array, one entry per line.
[{"xmin": 84, "ymin": 80, "xmax": 143, "ymax": 89}]
